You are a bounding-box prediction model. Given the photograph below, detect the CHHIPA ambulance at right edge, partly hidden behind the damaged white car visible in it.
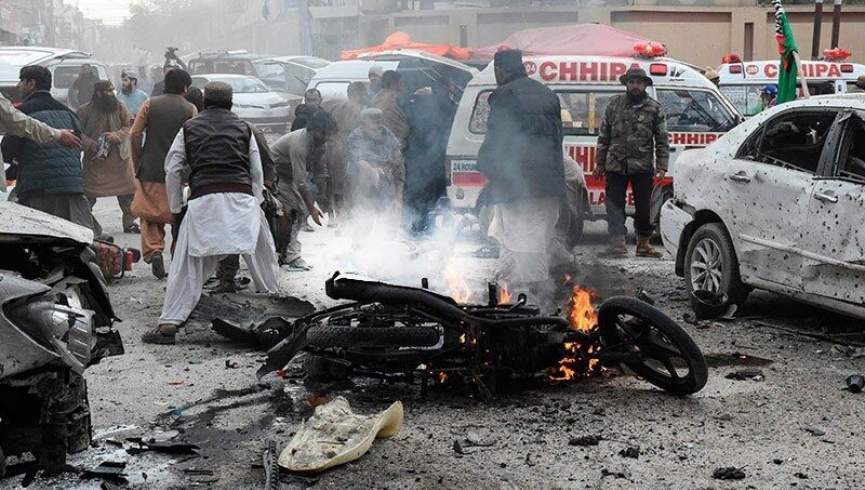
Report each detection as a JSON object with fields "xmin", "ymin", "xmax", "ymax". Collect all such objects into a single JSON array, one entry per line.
[{"xmin": 717, "ymin": 50, "xmax": 865, "ymax": 117}]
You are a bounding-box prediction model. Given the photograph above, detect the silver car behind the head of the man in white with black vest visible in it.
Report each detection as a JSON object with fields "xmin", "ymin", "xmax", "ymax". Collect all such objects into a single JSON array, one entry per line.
[{"xmin": 192, "ymin": 74, "xmax": 300, "ymax": 133}]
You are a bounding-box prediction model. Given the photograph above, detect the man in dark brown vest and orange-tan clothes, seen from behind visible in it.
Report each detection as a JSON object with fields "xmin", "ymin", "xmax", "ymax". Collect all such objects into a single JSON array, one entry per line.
[{"xmin": 129, "ymin": 69, "xmax": 198, "ymax": 279}]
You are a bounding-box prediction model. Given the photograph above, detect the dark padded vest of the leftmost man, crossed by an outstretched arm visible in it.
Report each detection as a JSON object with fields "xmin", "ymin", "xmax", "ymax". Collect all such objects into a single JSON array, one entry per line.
[{"xmin": 2, "ymin": 91, "xmax": 84, "ymax": 197}]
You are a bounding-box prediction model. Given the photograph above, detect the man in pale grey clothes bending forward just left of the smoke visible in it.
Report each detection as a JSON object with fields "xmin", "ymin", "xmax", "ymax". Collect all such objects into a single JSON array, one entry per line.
[{"xmin": 270, "ymin": 111, "xmax": 336, "ymax": 270}]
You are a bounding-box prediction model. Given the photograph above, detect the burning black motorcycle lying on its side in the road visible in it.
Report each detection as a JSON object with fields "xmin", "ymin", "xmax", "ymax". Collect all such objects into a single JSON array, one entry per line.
[{"xmin": 259, "ymin": 273, "xmax": 708, "ymax": 397}]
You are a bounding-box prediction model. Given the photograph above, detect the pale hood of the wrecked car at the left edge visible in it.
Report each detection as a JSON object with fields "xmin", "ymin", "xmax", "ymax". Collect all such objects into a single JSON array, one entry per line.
[{"xmin": 0, "ymin": 201, "xmax": 93, "ymax": 244}]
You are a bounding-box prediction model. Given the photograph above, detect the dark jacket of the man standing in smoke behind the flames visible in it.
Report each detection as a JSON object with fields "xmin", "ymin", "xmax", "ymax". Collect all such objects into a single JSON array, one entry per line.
[{"xmin": 478, "ymin": 76, "xmax": 565, "ymax": 204}]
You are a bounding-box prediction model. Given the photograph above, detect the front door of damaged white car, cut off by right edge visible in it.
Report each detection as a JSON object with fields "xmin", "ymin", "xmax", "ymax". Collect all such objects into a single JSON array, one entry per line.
[{"xmin": 800, "ymin": 111, "xmax": 865, "ymax": 306}]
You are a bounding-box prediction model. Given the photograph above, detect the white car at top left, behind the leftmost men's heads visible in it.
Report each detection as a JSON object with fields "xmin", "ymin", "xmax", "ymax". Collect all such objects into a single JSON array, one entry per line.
[{"xmin": 0, "ymin": 46, "xmax": 111, "ymax": 104}]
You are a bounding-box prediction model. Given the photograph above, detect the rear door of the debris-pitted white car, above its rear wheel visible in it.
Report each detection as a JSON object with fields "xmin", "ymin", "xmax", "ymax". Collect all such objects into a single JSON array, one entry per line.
[{"xmin": 719, "ymin": 109, "xmax": 837, "ymax": 291}]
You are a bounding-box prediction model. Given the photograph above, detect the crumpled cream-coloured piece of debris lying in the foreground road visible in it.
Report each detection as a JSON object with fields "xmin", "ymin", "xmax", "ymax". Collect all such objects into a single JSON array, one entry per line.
[{"xmin": 279, "ymin": 397, "xmax": 404, "ymax": 473}]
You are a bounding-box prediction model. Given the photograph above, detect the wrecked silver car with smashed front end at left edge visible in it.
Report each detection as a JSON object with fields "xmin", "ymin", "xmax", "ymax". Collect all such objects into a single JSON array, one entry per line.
[{"xmin": 0, "ymin": 202, "xmax": 123, "ymax": 476}]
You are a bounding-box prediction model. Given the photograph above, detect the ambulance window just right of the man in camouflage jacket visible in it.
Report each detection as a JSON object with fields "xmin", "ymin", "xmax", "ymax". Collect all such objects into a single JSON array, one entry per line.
[{"xmin": 657, "ymin": 89, "xmax": 737, "ymax": 133}]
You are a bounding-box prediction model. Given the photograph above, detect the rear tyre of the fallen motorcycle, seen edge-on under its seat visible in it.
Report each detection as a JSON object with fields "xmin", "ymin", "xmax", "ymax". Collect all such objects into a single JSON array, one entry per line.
[{"xmin": 306, "ymin": 325, "xmax": 440, "ymax": 349}]
